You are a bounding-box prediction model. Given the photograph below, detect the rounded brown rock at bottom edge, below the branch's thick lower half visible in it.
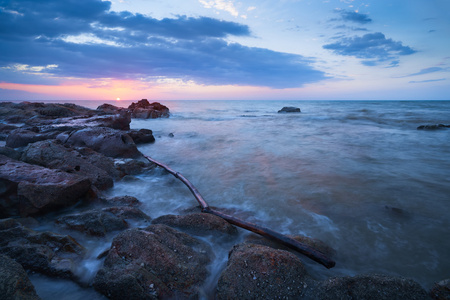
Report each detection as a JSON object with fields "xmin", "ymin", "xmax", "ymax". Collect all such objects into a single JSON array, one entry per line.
[{"xmin": 216, "ymin": 244, "xmax": 312, "ymax": 299}]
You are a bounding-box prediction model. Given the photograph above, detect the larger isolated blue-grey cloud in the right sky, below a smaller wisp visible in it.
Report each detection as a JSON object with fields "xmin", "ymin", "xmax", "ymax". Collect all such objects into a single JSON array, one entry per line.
[{"xmin": 323, "ymin": 32, "xmax": 417, "ymax": 66}]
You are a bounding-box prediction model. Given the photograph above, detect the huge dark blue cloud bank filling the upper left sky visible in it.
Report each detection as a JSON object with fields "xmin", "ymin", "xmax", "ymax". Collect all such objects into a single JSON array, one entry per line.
[{"xmin": 0, "ymin": 0, "xmax": 325, "ymax": 88}]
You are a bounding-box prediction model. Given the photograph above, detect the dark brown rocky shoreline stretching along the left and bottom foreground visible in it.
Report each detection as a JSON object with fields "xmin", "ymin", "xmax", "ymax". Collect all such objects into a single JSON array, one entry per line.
[{"xmin": 0, "ymin": 99, "xmax": 450, "ymax": 299}]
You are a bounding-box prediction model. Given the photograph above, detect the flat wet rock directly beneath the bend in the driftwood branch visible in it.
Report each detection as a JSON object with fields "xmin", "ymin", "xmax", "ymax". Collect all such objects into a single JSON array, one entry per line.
[{"xmin": 152, "ymin": 213, "xmax": 238, "ymax": 236}]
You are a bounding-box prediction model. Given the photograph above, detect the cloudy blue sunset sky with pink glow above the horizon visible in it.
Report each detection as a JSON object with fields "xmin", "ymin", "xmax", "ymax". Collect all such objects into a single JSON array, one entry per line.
[{"xmin": 0, "ymin": 0, "xmax": 450, "ymax": 101}]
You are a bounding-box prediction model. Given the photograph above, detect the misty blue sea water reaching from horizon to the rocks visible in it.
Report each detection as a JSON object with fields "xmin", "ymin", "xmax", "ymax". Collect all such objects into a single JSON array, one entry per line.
[{"xmin": 1, "ymin": 100, "xmax": 450, "ymax": 299}]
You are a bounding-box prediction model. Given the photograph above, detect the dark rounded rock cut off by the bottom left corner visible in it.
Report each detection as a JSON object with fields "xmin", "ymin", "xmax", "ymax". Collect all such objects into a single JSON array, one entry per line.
[{"xmin": 0, "ymin": 254, "xmax": 40, "ymax": 300}]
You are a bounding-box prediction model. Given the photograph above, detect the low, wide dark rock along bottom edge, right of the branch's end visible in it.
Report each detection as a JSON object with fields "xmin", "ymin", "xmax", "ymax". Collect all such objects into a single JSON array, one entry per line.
[{"xmin": 307, "ymin": 274, "xmax": 430, "ymax": 300}]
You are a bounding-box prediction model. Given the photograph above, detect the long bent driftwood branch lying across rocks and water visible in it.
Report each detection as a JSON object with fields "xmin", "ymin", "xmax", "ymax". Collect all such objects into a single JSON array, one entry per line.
[{"xmin": 144, "ymin": 155, "xmax": 336, "ymax": 269}]
